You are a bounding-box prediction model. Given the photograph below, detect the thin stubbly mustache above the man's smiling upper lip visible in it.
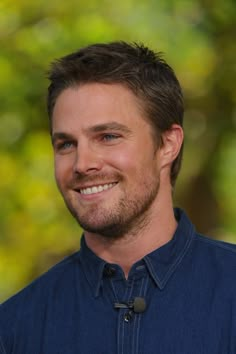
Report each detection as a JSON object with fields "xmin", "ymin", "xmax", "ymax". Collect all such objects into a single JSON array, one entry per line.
[{"xmin": 69, "ymin": 173, "xmax": 122, "ymax": 189}]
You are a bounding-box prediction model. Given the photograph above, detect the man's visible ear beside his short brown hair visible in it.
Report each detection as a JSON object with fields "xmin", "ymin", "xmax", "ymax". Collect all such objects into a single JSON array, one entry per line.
[{"xmin": 160, "ymin": 124, "xmax": 184, "ymax": 167}]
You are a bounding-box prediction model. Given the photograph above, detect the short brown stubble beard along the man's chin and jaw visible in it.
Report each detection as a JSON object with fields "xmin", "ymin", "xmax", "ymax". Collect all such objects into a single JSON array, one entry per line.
[{"xmin": 65, "ymin": 178, "xmax": 160, "ymax": 240}]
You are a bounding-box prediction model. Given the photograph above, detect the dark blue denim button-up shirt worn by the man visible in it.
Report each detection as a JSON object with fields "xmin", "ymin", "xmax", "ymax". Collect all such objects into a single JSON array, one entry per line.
[{"xmin": 0, "ymin": 210, "xmax": 236, "ymax": 354}]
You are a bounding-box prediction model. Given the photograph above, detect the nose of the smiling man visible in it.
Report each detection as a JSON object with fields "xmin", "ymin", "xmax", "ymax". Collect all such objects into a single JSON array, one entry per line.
[{"xmin": 73, "ymin": 144, "xmax": 102, "ymax": 174}]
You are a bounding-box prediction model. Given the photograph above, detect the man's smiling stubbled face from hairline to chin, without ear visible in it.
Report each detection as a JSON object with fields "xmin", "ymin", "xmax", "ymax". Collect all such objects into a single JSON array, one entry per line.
[{"xmin": 52, "ymin": 83, "xmax": 164, "ymax": 237}]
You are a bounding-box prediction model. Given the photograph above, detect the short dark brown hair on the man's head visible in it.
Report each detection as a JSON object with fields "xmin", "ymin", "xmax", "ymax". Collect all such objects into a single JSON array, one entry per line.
[{"xmin": 47, "ymin": 41, "xmax": 184, "ymax": 186}]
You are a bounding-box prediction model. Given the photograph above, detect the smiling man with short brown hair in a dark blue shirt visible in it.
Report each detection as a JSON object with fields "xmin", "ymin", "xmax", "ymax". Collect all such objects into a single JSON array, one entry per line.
[{"xmin": 0, "ymin": 42, "xmax": 236, "ymax": 354}]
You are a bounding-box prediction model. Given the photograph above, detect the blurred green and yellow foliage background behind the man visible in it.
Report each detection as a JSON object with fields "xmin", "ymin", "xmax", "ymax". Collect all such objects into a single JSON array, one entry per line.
[{"xmin": 0, "ymin": 0, "xmax": 236, "ymax": 301}]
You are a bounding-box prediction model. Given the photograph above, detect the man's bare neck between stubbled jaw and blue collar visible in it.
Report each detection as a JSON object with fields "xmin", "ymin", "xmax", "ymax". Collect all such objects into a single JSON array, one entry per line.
[{"xmin": 85, "ymin": 184, "xmax": 177, "ymax": 277}]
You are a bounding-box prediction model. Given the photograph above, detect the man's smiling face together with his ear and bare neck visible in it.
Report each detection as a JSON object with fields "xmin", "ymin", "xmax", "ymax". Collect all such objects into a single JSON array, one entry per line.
[{"xmin": 52, "ymin": 83, "xmax": 183, "ymax": 276}]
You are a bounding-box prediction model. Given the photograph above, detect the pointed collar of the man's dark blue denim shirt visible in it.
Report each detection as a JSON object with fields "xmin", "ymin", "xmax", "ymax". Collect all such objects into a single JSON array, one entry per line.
[{"xmin": 79, "ymin": 209, "xmax": 195, "ymax": 297}]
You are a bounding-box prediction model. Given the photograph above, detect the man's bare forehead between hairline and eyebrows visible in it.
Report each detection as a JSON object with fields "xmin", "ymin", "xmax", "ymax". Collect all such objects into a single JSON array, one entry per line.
[{"xmin": 52, "ymin": 83, "xmax": 148, "ymax": 130}]
